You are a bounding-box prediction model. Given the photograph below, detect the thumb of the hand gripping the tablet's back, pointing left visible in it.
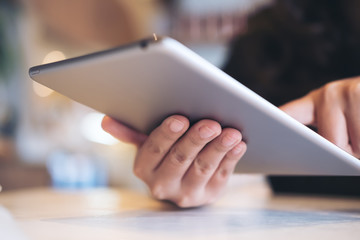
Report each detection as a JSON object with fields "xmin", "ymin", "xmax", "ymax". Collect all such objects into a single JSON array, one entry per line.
[{"xmin": 101, "ymin": 116, "xmax": 147, "ymax": 147}]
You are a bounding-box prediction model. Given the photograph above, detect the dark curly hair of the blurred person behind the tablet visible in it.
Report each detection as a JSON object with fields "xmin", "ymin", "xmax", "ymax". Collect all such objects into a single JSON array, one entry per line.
[{"xmin": 223, "ymin": 0, "xmax": 360, "ymax": 105}]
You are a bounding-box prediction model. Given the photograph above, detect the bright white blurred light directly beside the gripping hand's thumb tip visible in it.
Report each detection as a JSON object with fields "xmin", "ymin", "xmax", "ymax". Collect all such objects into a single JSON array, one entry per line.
[{"xmin": 81, "ymin": 113, "xmax": 119, "ymax": 145}]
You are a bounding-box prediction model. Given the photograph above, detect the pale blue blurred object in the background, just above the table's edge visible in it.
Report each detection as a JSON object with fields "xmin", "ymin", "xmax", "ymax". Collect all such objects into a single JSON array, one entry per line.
[{"xmin": 47, "ymin": 150, "xmax": 108, "ymax": 189}]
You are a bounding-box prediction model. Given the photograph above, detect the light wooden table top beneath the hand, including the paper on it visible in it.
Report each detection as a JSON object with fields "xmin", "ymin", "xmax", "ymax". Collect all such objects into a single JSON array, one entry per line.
[{"xmin": 0, "ymin": 175, "xmax": 360, "ymax": 240}]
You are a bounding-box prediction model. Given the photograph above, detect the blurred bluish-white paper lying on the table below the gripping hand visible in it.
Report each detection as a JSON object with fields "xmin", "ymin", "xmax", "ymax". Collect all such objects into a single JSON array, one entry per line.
[{"xmin": 48, "ymin": 208, "xmax": 360, "ymax": 236}]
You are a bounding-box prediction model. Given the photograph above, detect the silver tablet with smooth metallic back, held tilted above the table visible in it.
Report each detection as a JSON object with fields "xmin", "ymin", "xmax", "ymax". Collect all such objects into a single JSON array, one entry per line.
[{"xmin": 29, "ymin": 36, "xmax": 360, "ymax": 175}]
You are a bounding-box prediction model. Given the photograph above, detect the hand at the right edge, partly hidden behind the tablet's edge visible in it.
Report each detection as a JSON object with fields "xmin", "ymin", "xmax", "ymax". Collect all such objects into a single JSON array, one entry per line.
[{"xmin": 280, "ymin": 77, "xmax": 360, "ymax": 158}]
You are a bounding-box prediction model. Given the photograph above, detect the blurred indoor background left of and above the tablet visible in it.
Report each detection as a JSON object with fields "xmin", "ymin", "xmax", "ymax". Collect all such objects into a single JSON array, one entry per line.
[{"xmin": 0, "ymin": 0, "xmax": 272, "ymax": 190}]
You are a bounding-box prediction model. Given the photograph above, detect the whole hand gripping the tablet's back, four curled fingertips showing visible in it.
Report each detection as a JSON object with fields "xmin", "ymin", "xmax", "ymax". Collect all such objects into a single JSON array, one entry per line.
[{"xmin": 102, "ymin": 115, "xmax": 246, "ymax": 207}]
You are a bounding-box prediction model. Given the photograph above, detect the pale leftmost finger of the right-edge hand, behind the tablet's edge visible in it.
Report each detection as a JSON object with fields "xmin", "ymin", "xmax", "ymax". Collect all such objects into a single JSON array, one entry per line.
[{"xmin": 279, "ymin": 95, "xmax": 315, "ymax": 125}]
